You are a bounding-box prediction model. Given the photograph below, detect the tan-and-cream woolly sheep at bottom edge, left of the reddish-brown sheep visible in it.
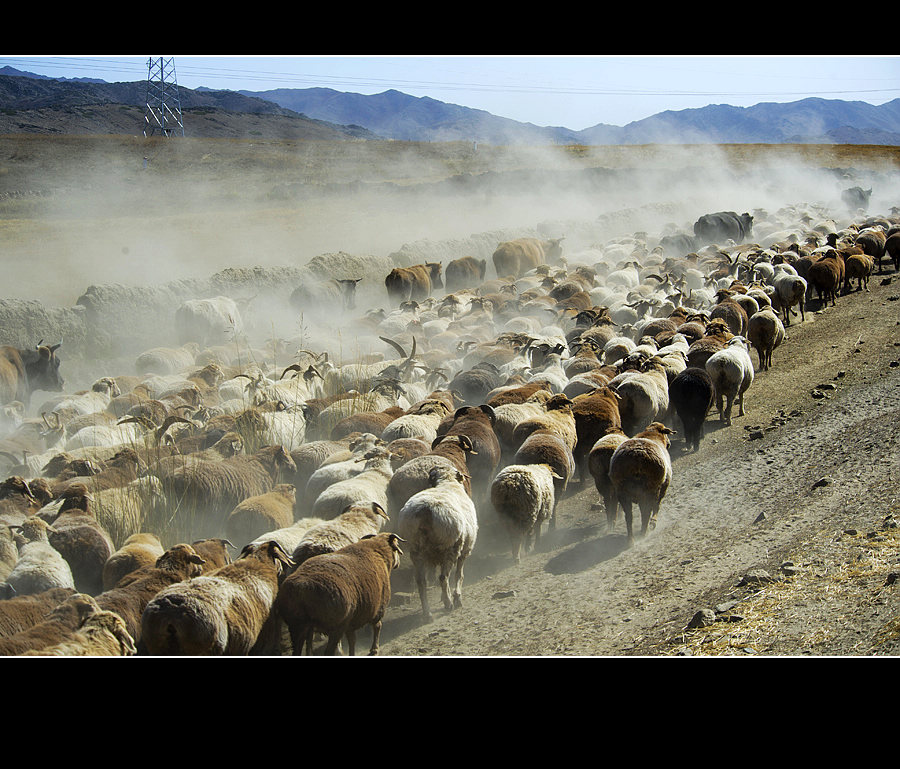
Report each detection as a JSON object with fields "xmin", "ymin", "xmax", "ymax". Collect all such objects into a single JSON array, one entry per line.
[{"xmin": 141, "ymin": 542, "xmax": 293, "ymax": 656}]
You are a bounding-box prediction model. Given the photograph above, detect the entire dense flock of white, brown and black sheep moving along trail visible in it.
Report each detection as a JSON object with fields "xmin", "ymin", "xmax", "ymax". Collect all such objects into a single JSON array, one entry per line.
[{"xmin": 0, "ymin": 190, "xmax": 900, "ymax": 656}]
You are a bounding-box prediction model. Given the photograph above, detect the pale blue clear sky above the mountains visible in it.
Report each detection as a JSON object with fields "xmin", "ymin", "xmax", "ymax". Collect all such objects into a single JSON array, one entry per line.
[{"xmin": 0, "ymin": 55, "xmax": 900, "ymax": 131}]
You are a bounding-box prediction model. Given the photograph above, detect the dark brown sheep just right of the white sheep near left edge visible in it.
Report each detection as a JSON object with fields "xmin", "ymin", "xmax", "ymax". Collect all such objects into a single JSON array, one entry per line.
[{"xmin": 48, "ymin": 484, "xmax": 116, "ymax": 595}]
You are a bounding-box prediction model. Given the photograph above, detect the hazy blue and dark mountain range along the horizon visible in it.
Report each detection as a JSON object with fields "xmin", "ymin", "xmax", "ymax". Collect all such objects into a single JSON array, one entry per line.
[{"xmin": 0, "ymin": 67, "xmax": 900, "ymax": 145}]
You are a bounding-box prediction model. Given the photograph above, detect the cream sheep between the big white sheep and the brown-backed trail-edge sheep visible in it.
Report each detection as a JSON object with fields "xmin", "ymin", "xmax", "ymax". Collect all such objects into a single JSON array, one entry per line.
[{"xmin": 491, "ymin": 464, "xmax": 559, "ymax": 563}]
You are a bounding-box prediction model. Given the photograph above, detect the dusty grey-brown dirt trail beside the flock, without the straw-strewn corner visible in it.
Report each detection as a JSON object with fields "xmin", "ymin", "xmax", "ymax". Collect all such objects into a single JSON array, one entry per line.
[{"xmin": 372, "ymin": 277, "xmax": 900, "ymax": 656}]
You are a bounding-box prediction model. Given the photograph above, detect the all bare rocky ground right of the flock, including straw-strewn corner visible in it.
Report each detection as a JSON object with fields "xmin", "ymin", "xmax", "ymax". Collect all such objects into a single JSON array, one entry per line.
[{"xmin": 372, "ymin": 270, "xmax": 900, "ymax": 656}]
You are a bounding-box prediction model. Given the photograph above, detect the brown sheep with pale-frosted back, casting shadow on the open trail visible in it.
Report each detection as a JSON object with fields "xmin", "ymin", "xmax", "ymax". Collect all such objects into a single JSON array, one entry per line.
[{"xmin": 609, "ymin": 422, "xmax": 675, "ymax": 546}]
